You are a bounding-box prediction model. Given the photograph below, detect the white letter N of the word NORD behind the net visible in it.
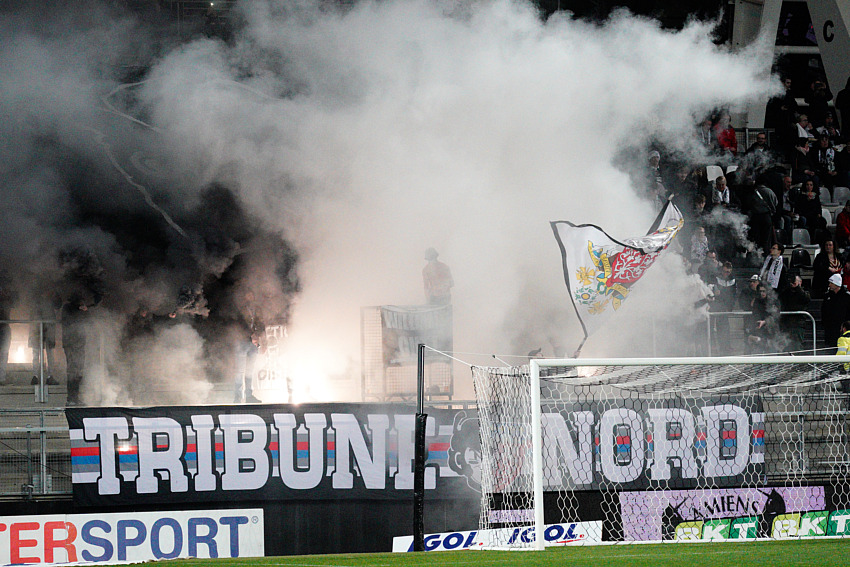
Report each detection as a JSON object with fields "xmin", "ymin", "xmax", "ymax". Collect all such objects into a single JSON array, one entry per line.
[{"xmin": 541, "ymin": 411, "xmax": 593, "ymax": 487}]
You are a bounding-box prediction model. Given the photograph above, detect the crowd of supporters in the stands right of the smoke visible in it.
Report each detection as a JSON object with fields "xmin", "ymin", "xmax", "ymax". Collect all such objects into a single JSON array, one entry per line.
[{"xmin": 641, "ymin": 81, "xmax": 850, "ymax": 355}]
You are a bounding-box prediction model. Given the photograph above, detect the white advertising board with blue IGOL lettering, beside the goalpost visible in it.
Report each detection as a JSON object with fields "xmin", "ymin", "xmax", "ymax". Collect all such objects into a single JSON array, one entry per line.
[{"xmin": 393, "ymin": 520, "xmax": 602, "ymax": 553}]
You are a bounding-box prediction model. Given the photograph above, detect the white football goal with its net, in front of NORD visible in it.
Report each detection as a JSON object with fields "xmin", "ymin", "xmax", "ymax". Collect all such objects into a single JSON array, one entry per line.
[{"xmin": 473, "ymin": 356, "xmax": 850, "ymax": 549}]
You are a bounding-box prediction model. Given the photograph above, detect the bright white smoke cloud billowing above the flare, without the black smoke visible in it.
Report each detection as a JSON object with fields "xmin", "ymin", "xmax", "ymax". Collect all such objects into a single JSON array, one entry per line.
[{"xmin": 3, "ymin": 0, "xmax": 775, "ymax": 399}]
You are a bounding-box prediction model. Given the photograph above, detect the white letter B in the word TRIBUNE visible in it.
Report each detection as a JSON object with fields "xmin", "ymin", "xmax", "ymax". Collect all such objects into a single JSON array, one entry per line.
[{"xmin": 218, "ymin": 414, "xmax": 270, "ymax": 490}]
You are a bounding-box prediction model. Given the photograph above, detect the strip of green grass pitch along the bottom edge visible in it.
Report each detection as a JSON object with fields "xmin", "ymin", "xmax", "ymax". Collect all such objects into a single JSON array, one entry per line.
[{"xmin": 167, "ymin": 539, "xmax": 850, "ymax": 567}]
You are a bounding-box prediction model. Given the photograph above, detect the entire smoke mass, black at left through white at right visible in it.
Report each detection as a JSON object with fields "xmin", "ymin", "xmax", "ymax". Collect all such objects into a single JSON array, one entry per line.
[{"xmin": 0, "ymin": 0, "xmax": 774, "ymax": 403}]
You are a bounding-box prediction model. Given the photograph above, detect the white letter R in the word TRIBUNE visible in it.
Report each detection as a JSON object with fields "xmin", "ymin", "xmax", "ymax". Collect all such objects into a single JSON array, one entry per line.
[{"xmin": 133, "ymin": 417, "xmax": 189, "ymax": 494}]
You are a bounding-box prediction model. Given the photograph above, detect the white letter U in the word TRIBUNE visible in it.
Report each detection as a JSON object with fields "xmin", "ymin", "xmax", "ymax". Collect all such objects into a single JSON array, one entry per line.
[{"xmin": 274, "ymin": 413, "xmax": 327, "ymax": 489}]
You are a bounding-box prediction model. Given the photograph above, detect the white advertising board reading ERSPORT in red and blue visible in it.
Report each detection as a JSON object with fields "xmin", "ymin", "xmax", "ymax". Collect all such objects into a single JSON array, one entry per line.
[{"xmin": 0, "ymin": 509, "xmax": 264, "ymax": 565}]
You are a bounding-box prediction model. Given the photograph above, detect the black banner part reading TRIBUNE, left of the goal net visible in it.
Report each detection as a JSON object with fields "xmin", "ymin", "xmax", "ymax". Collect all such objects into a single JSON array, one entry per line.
[{"xmin": 66, "ymin": 404, "xmax": 479, "ymax": 506}]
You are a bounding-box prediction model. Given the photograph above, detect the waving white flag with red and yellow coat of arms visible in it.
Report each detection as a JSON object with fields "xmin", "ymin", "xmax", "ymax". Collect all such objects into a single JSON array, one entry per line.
[{"xmin": 550, "ymin": 200, "xmax": 684, "ymax": 356}]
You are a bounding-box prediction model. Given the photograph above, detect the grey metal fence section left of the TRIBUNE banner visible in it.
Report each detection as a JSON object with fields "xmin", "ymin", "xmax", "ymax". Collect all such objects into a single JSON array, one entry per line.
[{"xmin": 0, "ymin": 408, "xmax": 71, "ymax": 499}]
